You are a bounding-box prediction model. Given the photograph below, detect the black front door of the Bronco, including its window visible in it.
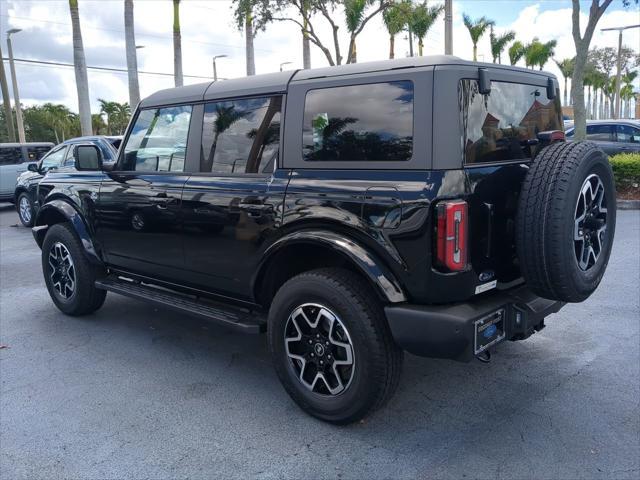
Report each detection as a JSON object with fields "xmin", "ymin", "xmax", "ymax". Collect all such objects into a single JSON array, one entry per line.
[{"xmin": 96, "ymin": 105, "xmax": 192, "ymax": 281}]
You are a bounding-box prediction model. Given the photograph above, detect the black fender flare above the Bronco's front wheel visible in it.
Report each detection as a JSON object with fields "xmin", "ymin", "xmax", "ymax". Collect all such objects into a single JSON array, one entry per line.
[{"xmin": 31, "ymin": 198, "xmax": 102, "ymax": 265}]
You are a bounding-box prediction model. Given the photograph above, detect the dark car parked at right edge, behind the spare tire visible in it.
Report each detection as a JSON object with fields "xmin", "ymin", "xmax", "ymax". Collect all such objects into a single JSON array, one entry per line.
[{"xmin": 566, "ymin": 120, "xmax": 640, "ymax": 155}]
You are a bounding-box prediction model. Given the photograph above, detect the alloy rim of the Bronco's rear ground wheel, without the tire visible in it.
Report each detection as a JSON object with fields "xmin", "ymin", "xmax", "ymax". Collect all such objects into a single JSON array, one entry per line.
[{"xmin": 284, "ymin": 303, "xmax": 355, "ymax": 396}]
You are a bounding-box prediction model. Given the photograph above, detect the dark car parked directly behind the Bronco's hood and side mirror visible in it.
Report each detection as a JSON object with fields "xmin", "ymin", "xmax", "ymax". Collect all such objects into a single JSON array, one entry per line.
[{"xmin": 12, "ymin": 136, "xmax": 122, "ymax": 227}]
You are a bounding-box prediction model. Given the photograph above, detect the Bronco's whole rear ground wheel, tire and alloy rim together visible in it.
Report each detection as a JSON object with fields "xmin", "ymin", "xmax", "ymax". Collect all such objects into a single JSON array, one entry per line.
[{"xmin": 268, "ymin": 269, "xmax": 403, "ymax": 424}]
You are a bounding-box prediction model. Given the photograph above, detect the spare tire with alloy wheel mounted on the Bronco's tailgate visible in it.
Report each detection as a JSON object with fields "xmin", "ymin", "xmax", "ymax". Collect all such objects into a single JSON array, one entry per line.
[{"xmin": 516, "ymin": 142, "xmax": 616, "ymax": 302}]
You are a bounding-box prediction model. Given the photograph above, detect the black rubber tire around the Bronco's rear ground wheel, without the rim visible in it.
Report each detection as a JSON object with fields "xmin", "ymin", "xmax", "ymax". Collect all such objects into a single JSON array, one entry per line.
[{"xmin": 268, "ymin": 268, "xmax": 403, "ymax": 424}]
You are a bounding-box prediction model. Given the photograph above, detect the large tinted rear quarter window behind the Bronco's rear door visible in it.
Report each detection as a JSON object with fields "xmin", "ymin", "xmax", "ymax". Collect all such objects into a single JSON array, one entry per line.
[{"xmin": 302, "ymin": 80, "xmax": 413, "ymax": 162}]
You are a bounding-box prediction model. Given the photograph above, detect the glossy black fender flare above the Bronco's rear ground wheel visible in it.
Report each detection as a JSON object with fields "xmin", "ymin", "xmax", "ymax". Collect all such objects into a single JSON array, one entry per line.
[{"xmin": 252, "ymin": 230, "xmax": 407, "ymax": 303}]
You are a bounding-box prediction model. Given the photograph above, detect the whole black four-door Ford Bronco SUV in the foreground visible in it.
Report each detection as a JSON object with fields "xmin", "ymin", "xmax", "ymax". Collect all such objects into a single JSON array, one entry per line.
[{"xmin": 33, "ymin": 56, "xmax": 616, "ymax": 423}]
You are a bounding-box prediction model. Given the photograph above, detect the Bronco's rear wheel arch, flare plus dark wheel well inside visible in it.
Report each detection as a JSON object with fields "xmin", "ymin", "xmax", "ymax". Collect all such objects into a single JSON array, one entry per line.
[{"xmin": 252, "ymin": 230, "xmax": 407, "ymax": 306}]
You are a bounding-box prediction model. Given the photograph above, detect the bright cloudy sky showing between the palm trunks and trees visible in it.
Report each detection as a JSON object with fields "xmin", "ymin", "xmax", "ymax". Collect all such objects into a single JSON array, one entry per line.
[{"xmin": 0, "ymin": 0, "xmax": 640, "ymax": 111}]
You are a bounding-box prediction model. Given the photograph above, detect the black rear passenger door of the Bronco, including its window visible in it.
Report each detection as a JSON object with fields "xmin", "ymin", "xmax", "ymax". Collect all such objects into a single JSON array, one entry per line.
[{"xmin": 182, "ymin": 95, "xmax": 288, "ymax": 298}]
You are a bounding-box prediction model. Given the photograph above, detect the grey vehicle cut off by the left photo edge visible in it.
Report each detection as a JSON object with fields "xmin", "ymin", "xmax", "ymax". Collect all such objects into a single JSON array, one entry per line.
[{"xmin": 0, "ymin": 142, "xmax": 53, "ymax": 202}]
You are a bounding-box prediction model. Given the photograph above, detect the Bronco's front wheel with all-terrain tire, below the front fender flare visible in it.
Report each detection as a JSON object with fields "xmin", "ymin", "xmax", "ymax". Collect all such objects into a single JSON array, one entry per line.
[{"xmin": 42, "ymin": 223, "xmax": 107, "ymax": 316}]
